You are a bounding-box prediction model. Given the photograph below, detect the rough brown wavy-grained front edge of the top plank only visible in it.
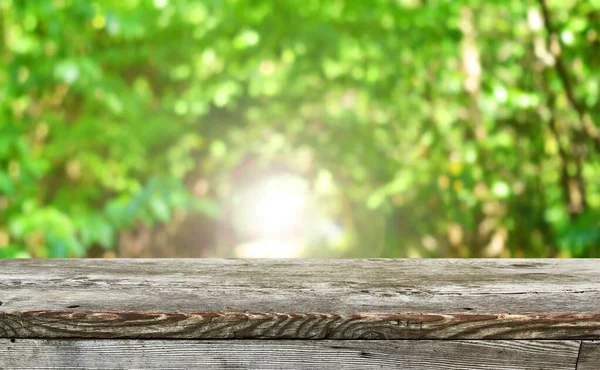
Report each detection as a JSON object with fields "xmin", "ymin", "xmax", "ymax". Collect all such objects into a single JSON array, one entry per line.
[{"xmin": 0, "ymin": 311, "xmax": 600, "ymax": 340}]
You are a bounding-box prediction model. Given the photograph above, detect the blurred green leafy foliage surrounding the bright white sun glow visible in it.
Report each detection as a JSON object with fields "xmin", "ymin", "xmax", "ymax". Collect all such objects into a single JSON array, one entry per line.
[{"xmin": 0, "ymin": 0, "xmax": 600, "ymax": 257}]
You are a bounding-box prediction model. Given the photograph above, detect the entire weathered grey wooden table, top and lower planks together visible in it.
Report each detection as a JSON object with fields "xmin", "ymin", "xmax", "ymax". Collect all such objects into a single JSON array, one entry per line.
[{"xmin": 0, "ymin": 259, "xmax": 600, "ymax": 370}]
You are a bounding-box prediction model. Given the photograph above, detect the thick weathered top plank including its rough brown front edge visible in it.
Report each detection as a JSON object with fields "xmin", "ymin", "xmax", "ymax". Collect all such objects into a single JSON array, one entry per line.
[{"xmin": 0, "ymin": 259, "xmax": 600, "ymax": 339}]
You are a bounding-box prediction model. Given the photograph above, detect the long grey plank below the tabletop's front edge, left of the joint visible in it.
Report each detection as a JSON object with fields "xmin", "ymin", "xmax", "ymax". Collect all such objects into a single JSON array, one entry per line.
[{"xmin": 0, "ymin": 339, "xmax": 579, "ymax": 370}]
